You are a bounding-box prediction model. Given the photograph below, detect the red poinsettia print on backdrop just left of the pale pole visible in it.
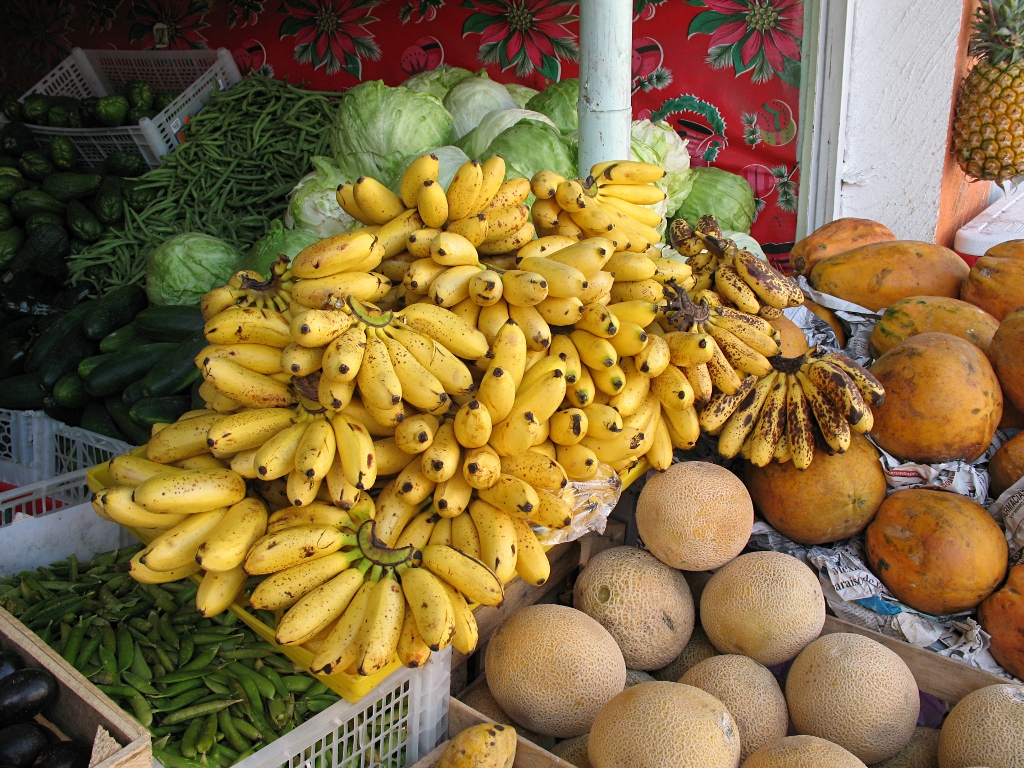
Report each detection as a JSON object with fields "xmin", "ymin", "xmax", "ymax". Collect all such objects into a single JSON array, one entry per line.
[{"xmin": 462, "ymin": 0, "xmax": 580, "ymax": 80}]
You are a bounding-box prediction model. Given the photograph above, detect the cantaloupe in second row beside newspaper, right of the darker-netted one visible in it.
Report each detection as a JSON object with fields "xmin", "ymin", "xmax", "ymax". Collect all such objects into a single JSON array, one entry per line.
[{"xmin": 700, "ymin": 552, "xmax": 825, "ymax": 667}]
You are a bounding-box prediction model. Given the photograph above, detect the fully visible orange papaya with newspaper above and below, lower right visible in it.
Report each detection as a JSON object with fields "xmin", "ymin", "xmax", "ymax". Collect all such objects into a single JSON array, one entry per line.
[{"xmin": 864, "ymin": 488, "xmax": 1010, "ymax": 616}]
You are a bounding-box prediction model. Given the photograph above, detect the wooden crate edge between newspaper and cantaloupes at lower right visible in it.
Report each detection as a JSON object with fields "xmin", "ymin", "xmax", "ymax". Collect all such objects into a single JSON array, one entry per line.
[{"xmin": 821, "ymin": 616, "xmax": 1007, "ymax": 703}]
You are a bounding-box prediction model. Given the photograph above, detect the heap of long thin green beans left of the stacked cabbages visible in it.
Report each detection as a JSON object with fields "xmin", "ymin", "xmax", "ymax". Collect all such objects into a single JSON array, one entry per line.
[{"xmin": 68, "ymin": 75, "xmax": 338, "ymax": 294}]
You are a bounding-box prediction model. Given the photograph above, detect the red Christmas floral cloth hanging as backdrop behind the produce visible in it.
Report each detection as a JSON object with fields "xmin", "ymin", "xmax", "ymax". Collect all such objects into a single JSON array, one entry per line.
[{"xmin": 0, "ymin": 0, "xmax": 803, "ymax": 262}]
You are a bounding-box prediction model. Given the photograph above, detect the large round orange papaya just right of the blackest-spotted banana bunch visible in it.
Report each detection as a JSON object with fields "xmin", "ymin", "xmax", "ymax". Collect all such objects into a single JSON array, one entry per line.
[{"xmin": 870, "ymin": 333, "xmax": 1002, "ymax": 464}]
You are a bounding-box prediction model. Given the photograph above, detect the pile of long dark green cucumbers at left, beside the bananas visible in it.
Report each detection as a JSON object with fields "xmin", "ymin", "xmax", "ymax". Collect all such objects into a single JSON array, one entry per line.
[{"xmin": 0, "ymin": 286, "xmax": 206, "ymax": 445}]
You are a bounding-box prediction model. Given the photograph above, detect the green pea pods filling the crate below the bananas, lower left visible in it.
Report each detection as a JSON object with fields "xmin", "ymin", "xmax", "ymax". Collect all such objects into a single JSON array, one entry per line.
[{"xmin": 0, "ymin": 545, "xmax": 360, "ymax": 768}]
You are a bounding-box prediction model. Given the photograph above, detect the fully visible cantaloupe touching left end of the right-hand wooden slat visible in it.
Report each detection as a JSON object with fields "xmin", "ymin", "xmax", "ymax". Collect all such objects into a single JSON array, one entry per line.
[{"xmin": 785, "ymin": 632, "xmax": 921, "ymax": 763}]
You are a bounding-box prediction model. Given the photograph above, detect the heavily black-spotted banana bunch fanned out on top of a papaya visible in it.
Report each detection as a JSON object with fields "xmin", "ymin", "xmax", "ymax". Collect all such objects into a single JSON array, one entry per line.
[{"xmin": 700, "ymin": 349, "xmax": 885, "ymax": 469}]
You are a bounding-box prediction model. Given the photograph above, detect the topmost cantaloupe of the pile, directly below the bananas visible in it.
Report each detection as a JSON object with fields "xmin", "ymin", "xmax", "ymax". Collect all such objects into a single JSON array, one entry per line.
[{"xmin": 636, "ymin": 462, "xmax": 754, "ymax": 570}]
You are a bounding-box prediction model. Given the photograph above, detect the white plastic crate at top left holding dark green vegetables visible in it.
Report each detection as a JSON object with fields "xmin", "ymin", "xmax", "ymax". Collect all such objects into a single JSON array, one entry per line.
[{"xmin": 20, "ymin": 48, "xmax": 242, "ymax": 168}]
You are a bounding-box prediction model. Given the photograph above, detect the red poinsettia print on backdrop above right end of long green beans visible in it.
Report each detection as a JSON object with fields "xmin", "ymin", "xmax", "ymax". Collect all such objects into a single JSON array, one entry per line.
[{"xmin": 278, "ymin": 0, "xmax": 384, "ymax": 80}]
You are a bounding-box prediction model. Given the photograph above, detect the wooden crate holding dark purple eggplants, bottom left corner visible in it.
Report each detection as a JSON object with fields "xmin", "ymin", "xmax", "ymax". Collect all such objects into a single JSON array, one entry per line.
[{"xmin": 0, "ymin": 609, "xmax": 153, "ymax": 768}]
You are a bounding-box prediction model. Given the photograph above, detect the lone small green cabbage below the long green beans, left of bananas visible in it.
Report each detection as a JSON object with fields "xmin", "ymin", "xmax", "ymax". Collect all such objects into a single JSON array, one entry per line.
[{"xmin": 145, "ymin": 232, "xmax": 242, "ymax": 305}]
